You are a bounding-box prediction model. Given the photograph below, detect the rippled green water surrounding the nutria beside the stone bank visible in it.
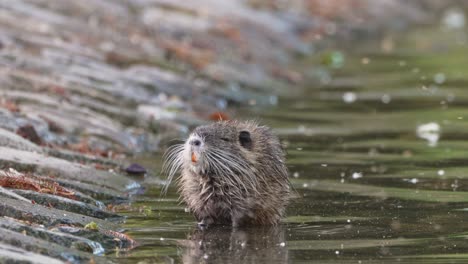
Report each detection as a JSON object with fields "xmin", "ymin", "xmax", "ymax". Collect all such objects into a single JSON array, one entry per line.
[{"xmin": 119, "ymin": 26, "xmax": 468, "ymax": 263}]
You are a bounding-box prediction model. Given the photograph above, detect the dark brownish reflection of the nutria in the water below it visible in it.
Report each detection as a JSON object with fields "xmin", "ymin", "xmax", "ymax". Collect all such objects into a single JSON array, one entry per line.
[{"xmin": 180, "ymin": 226, "xmax": 288, "ymax": 263}]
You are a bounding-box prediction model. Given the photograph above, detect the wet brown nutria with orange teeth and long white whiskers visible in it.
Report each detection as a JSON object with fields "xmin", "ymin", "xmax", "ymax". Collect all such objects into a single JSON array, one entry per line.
[{"xmin": 163, "ymin": 121, "xmax": 289, "ymax": 227}]
